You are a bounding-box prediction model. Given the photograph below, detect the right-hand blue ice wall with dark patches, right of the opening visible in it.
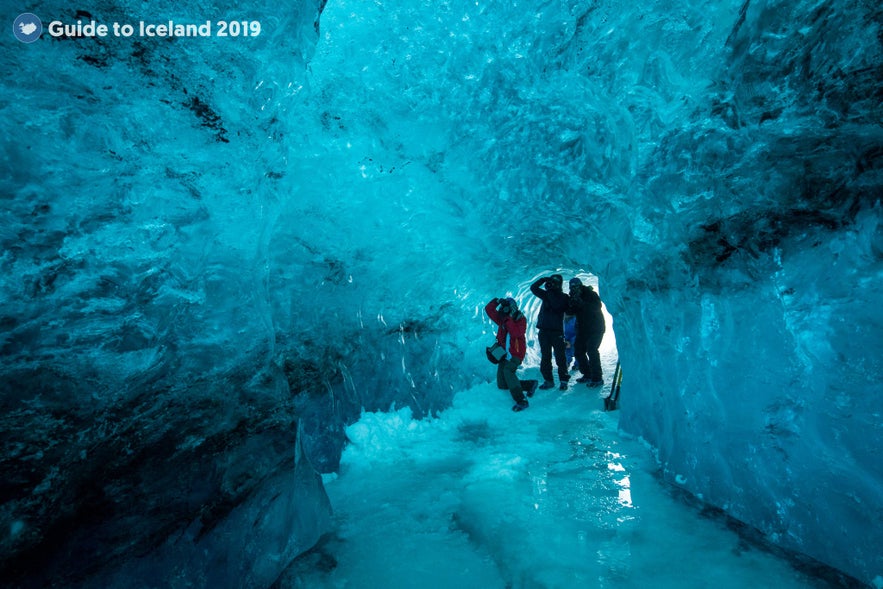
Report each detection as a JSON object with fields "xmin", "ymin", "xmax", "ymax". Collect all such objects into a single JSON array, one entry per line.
[{"xmin": 608, "ymin": 2, "xmax": 883, "ymax": 583}]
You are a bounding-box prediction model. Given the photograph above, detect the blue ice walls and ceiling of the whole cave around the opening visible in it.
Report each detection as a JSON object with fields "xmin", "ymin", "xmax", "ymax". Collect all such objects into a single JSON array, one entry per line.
[{"xmin": 0, "ymin": 0, "xmax": 883, "ymax": 584}]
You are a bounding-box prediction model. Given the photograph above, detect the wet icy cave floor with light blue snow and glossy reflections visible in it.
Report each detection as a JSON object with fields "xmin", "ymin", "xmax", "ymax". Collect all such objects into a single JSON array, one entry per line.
[{"xmin": 280, "ymin": 370, "xmax": 836, "ymax": 589}]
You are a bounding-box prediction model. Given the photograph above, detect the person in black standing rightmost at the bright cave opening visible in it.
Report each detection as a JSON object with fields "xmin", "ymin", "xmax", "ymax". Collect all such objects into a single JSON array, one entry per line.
[{"xmin": 569, "ymin": 278, "xmax": 606, "ymax": 387}]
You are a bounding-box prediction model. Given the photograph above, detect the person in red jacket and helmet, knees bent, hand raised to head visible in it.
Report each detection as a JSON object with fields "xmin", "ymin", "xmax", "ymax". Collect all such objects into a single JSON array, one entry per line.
[{"xmin": 484, "ymin": 297, "xmax": 538, "ymax": 411}]
